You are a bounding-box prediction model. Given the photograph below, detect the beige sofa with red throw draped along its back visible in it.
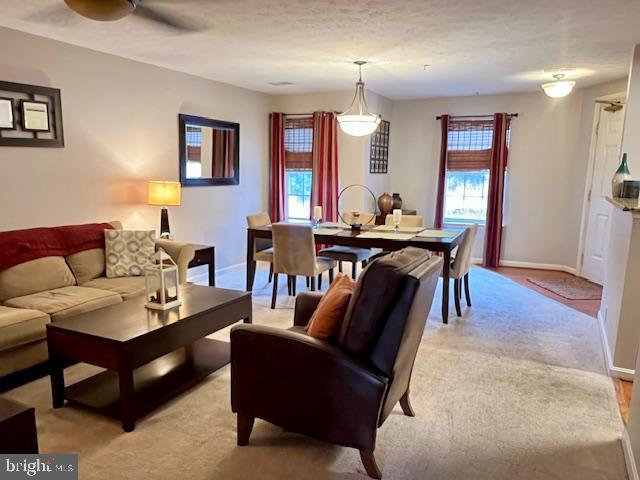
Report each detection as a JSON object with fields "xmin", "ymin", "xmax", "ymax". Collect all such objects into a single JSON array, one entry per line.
[{"xmin": 0, "ymin": 222, "xmax": 194, "ymax": 377}]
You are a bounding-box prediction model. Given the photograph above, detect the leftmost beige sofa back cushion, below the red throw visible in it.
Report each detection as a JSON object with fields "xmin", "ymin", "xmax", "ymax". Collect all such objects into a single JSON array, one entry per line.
[{"xmin": 0, "ymin": 257, "xmax": 76, "ymax": 302}]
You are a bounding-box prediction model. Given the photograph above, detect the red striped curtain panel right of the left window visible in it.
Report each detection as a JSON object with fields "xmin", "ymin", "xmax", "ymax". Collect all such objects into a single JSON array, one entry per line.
[{"xmin": 310, "ymin": 112, "xmax": 338, "ymax": 222}]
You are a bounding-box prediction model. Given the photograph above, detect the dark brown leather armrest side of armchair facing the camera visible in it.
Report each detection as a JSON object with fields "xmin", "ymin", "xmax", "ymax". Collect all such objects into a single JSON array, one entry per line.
[{"xmin": 231, "ymin": 325, "xmax": 388, "ymax": 450}]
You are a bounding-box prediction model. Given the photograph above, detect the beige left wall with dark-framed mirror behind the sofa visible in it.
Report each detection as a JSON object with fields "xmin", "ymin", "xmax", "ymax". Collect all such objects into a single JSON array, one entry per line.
[{"xmin": 0, "ymin": 28, "xmax": 270, "ymax": 267}]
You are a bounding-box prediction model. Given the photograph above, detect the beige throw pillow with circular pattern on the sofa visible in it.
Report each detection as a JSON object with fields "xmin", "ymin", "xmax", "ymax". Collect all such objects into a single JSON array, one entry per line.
[{"xmin": 104, "ymin": 230, "xmax": 156, "ymax": 278}]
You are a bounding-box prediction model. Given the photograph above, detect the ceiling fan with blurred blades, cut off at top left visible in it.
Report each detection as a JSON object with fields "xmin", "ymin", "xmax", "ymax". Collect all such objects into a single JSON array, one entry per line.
[{"xmin": 27, "ymin": 0, "xmax": 202, "ymax": 33}]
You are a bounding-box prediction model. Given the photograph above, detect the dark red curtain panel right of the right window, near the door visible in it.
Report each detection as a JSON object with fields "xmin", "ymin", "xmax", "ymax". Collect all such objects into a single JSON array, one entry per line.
[{"xmin": 484, "ymin": 113, "xmax": 510, "ymax": 267}]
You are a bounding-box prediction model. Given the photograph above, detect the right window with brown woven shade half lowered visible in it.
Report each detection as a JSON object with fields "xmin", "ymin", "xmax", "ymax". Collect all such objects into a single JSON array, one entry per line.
[{"xmin": 443, "ymin": 119, "xmax": 508, "ymax": 224}]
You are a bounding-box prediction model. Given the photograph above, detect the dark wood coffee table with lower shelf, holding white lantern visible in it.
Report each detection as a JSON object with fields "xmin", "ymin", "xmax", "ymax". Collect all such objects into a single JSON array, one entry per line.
[{"xmin": 47, "ymin": 285, "xmax": 251, "ymax": 432}]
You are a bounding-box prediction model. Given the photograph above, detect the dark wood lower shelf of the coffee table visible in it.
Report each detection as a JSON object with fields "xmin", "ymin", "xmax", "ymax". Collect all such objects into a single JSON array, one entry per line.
[{"xmin": 64, "ymin": 338, "xmax": 230, "ymax": 431}]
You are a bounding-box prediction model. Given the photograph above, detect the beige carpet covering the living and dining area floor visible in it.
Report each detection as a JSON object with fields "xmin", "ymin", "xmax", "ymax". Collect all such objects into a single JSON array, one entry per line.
[{"xmin": 3, "ymin": 269, "xmax": 627, "ymax": 480}]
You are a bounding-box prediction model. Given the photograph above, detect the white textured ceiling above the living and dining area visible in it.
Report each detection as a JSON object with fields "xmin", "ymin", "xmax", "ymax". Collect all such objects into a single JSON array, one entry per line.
[{"xmin": 0, "ymin": 0, "xmax": 640, "ymax": 99}]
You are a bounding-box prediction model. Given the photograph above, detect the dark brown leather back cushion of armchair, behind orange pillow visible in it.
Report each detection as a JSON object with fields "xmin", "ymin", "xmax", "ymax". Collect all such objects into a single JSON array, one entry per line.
[{"xmin": 338, "ymin": 247, "xmax": 431, "ymax": 355}]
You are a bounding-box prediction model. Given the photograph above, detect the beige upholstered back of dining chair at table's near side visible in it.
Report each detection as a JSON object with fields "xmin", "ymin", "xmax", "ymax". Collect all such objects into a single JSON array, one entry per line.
[{"xmin": 271, "ymin": 223, "xmax": 316, "ymax": 277}]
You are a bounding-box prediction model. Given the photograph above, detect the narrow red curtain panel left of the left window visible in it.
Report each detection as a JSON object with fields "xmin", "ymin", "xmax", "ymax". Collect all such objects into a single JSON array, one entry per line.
[{"xmin": 269, "ymin": 113, "xmax": 286, "ymax": 222}]
